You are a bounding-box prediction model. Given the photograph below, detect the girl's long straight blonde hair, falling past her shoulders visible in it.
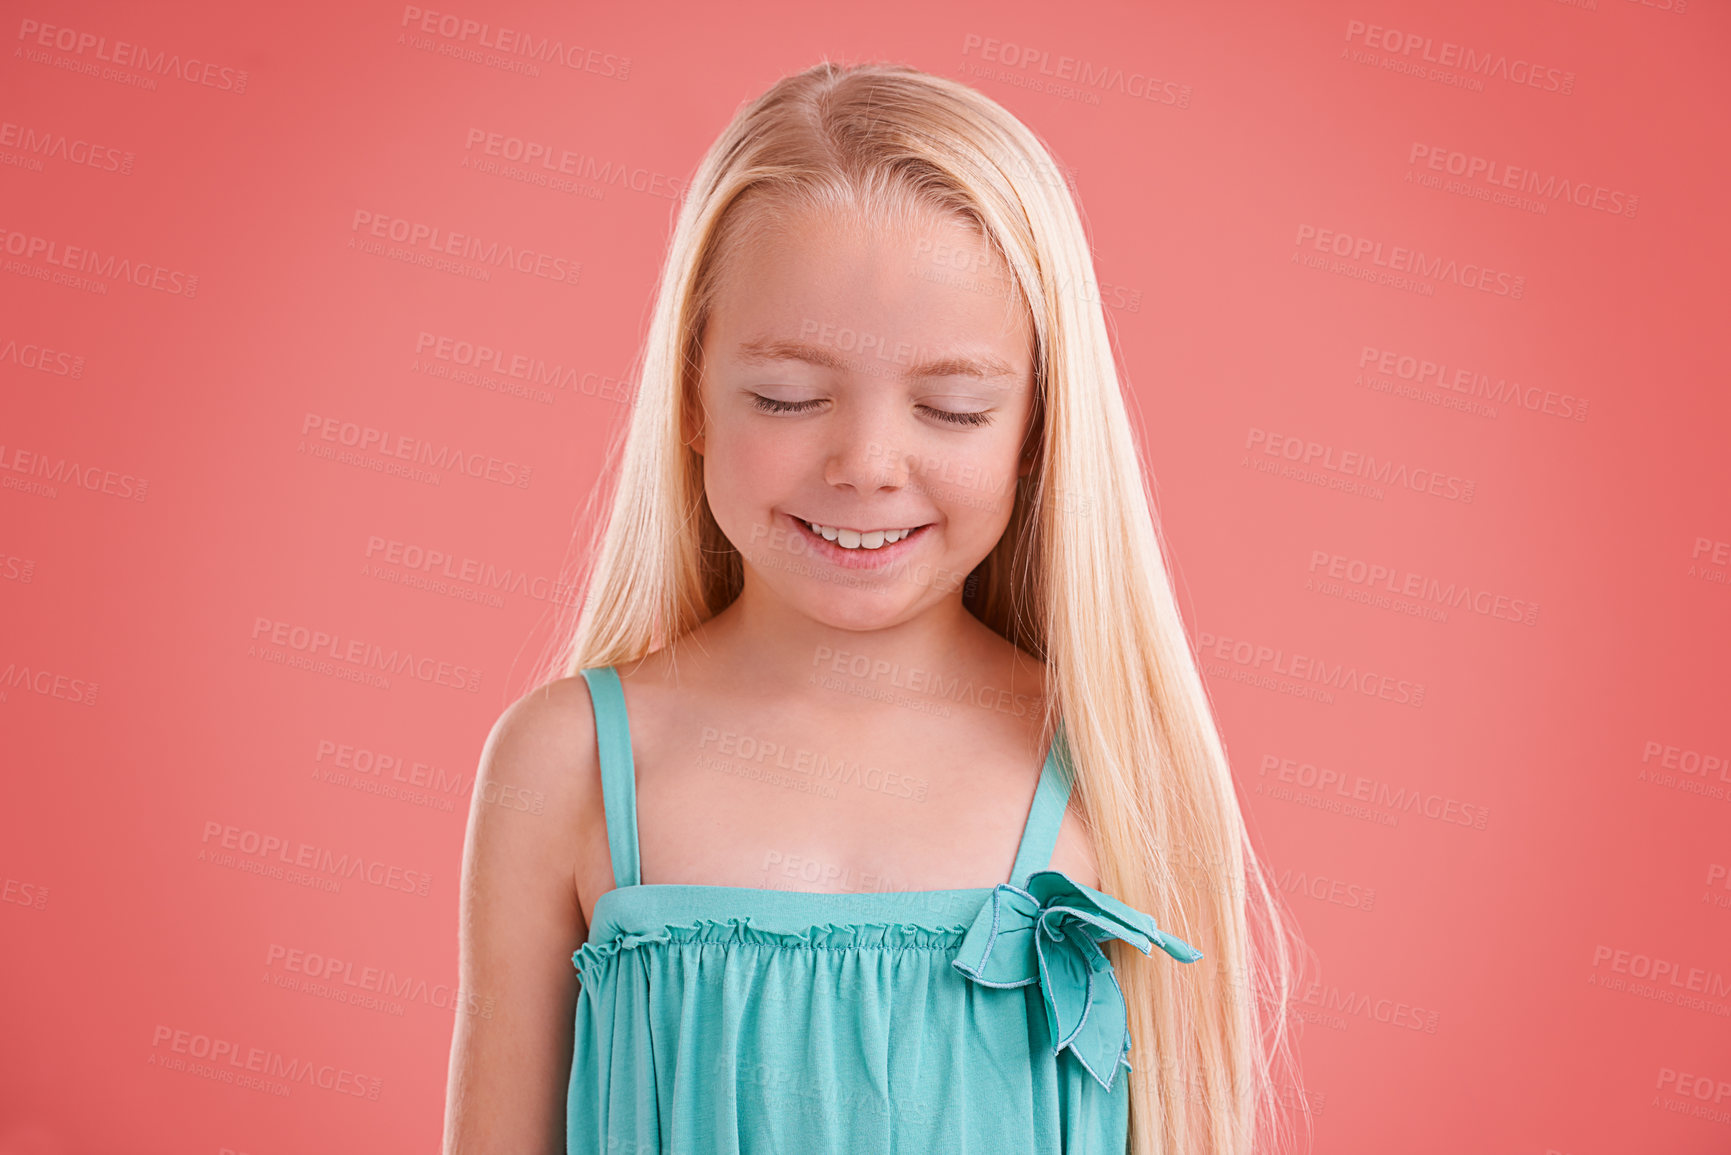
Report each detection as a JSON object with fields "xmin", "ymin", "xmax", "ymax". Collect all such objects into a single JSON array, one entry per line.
[{"xmin": 545, "ymin": 62, "xmax": 1309, "ymax": 1155}]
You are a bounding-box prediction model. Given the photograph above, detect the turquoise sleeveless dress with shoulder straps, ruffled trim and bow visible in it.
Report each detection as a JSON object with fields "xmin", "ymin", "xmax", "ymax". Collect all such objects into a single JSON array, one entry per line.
[{"xmin": 566, "ymin": 667, "xmax": 1201, "ymax": 1155}]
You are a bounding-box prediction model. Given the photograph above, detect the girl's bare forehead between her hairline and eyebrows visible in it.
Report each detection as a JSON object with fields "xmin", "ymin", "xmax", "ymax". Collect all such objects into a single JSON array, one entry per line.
[{"xmin": 705, "ymin": 210, "xmax": 1033, "ymax": 376}]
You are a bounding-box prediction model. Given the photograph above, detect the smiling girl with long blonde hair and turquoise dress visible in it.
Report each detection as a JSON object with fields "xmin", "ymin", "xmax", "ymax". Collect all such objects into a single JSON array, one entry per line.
[{"xmin": 445, "ymin": 62, "xmax": 1291, "ymax": 1155}]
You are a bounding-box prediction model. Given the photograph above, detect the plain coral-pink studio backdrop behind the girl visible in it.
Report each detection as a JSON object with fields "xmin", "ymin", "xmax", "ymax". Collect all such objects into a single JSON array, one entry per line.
[{"xmin": 0, "ymin": 0, "xmax": 1731, "ymax": 1155}]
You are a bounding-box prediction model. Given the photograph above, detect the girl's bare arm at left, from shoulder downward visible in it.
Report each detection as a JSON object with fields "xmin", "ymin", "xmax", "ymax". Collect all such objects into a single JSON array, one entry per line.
[{"xmin": 443, "ymin": 679, "xmax": 599, "ymax": 1155}]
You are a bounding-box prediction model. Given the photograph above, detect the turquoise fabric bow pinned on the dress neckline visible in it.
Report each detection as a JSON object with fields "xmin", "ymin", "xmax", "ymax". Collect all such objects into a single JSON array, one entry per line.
[{"xmin": 950, "ymin": 871, "xmax": 1201, "ymax": 1091}]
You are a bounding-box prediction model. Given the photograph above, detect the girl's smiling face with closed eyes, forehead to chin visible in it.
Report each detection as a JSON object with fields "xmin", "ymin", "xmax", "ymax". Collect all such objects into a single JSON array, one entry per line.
[{"xmin": 692, "ymin": 200, "xmax": 1033, "ymax": 630}]
